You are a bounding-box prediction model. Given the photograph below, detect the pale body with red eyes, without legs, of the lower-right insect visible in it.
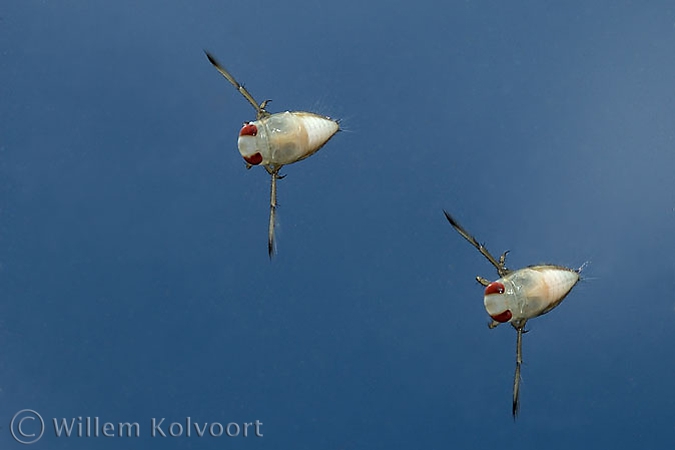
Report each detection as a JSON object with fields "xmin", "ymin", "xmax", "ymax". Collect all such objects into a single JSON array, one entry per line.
[{"xmin": 484, "ymin": 265, "xmax": 579, "ymax": 323}]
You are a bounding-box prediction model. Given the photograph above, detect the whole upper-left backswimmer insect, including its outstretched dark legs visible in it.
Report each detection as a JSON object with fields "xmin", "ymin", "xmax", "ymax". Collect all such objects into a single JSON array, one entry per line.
[{"xmin": 204, "ymin": 51, "xmax": 340, "ymax": 258}]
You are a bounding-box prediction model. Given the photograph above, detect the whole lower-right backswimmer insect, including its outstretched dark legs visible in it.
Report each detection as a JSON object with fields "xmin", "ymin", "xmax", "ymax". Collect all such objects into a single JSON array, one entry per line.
[{"xmin": 443, "ymin": 211, "xmax": 583, "ymax": 419}]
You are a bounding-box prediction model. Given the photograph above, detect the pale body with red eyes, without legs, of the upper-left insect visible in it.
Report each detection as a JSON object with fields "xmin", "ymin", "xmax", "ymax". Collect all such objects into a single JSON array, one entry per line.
[{"xmin": 238, "ymin": 111, "xmax": 340, "ymax": 167}]
